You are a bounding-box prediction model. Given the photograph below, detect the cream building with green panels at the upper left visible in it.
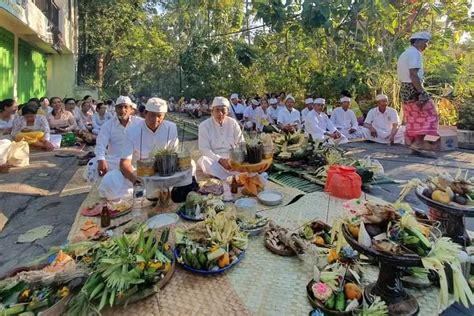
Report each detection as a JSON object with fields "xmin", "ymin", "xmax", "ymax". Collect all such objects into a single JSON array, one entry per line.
[{"xmin": 0, "ymin": 0, "xmax": 77, "ymax": 103}]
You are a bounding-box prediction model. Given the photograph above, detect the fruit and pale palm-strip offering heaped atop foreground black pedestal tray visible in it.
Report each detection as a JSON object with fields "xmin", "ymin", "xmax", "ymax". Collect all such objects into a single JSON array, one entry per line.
[{"xmin": 333, "ymin": 201, "xmax": 474, "ymax": 308}]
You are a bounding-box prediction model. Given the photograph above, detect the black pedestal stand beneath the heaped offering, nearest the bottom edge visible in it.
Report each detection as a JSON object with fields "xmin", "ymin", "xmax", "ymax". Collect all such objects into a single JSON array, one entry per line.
[{"xmin": 342, "ymin": 225, "xmax": 423, "ymax": 315}]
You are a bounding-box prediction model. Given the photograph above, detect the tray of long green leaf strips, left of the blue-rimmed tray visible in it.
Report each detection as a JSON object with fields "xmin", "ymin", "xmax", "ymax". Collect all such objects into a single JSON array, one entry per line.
[{"xmin": 66, "ymin": 227, "xmax": 175, "ymax": 315}]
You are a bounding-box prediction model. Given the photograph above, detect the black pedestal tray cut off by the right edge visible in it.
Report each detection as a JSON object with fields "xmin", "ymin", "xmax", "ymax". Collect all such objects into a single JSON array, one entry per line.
[{"xmin": 415, "ymin": 187, "xmax": 474, "ymax": 247}]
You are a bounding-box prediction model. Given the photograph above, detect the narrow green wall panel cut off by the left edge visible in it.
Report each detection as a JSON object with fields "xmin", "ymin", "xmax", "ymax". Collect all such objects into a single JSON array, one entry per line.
[{"xmin": 0, "ymin": 27, "xmax": 15, "ymax": 100}]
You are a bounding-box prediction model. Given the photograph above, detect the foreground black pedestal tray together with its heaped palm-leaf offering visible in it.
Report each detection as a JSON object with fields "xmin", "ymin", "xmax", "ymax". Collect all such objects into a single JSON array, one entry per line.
[{"xmin": 333, "ymin": 201, "xmax": 474, "ymax": 315}]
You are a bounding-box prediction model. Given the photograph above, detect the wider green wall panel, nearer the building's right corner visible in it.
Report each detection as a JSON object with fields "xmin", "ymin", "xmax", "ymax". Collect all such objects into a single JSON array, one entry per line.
[{"xmin": 17, "ymin": 40, "xmax": 47, "ymax": 103}]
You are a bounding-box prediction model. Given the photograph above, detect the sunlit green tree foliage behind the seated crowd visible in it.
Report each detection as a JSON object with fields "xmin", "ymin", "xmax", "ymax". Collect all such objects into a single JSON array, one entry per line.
[{"xmin": 80, "ymin": 0, "xmax": 474, "ymax": 110}]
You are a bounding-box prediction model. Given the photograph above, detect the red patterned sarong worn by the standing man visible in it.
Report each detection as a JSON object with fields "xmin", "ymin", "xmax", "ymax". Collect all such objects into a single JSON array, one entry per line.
[{"xmin": 403, "ymin": 100, "xmax": 438, "ymax": 138}]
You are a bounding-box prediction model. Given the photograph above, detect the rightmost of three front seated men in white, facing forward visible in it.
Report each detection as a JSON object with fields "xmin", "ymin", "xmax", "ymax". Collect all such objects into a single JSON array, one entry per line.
[{"xmin": 197, "ymin": 97, "xmax": 244, "ymax": 180}]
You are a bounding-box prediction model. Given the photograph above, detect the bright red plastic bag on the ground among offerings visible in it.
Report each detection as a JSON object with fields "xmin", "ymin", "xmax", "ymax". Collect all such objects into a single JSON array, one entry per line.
[{"xmin": 324, "ymin": 165, "xmax": 362, "ymax": 199}]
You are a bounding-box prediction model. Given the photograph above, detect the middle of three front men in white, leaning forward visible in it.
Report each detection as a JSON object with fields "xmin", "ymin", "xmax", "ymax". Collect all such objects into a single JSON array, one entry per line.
[{"xmin": 99, "ymin": 98, "xmax": 178, "ymax": 196}]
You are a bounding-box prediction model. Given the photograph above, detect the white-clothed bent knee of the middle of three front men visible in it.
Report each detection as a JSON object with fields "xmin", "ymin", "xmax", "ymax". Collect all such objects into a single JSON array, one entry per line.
[{"xmin": 99, "ymin": 170, "xmax": 133, "ymax": 201}]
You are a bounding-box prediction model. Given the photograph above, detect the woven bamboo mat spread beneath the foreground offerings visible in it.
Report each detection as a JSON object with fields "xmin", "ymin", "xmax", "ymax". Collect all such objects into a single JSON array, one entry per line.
[{"xmin": 69, "ymin": 184, "xmax": 452, "ymax": 315}]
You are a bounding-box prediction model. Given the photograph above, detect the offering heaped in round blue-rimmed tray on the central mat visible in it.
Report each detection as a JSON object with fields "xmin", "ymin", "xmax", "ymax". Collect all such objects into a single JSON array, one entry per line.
[{"xmin": 175, "ymin": 210, "xmax": 248, "ymax": 275}]
